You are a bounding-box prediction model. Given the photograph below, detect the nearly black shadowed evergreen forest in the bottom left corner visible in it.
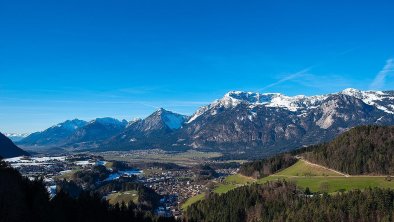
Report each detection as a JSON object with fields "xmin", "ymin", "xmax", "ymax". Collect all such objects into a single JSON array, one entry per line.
[{"xmin": 0, "ymin": 160, "xmax": 174, "ymax": 222}]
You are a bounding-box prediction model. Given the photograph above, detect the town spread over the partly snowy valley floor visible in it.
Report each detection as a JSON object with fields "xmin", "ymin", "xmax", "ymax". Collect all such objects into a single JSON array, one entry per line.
[{"xmin": 5, "ymin": 153, "xmax": 238, "ymax": 217}]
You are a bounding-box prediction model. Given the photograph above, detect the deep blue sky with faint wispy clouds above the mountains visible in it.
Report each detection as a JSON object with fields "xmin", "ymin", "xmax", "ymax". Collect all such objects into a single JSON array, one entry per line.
[{"xmin": 0, "ymin": 0, "xmax": 394, "ymax": 132}]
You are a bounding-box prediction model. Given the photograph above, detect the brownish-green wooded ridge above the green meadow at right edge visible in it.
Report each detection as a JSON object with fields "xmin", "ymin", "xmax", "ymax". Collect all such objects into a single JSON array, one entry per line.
[{"xmin": 301, "ymin": 126, "xmax": 394, "ymax": 175}]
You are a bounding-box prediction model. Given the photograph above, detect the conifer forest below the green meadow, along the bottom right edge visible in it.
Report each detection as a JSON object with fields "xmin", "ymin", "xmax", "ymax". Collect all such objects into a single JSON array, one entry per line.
[{"xmin": 185, "ymin": 182, "xmax": 394, "ymax": 222}]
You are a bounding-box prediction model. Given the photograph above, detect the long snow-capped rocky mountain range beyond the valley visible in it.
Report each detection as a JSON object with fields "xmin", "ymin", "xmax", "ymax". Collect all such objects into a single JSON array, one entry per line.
[{"xmin": 18, "ymin": 89, "xmax": 394, "ymax": 157}]
